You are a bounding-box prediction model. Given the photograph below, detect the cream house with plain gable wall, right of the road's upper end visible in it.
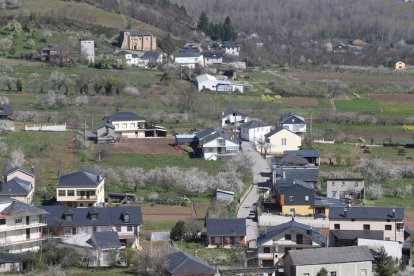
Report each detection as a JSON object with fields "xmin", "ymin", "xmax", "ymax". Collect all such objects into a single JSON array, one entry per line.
[{"xmin": 264, "ymin": 127, "xmax": 302, "ymax": 155}]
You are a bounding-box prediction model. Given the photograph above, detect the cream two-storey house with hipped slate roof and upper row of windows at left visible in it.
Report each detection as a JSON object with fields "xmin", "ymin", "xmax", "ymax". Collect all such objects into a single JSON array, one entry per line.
[{"xmin": 56, "ymin": 168, "xmax": 105, "ymax": 207}]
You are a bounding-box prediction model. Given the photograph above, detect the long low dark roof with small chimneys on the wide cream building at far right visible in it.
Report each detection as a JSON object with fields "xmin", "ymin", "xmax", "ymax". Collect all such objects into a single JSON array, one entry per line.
[{"xmin": 329, "ymin": 207, "xmax": 404, "ymax": 220}]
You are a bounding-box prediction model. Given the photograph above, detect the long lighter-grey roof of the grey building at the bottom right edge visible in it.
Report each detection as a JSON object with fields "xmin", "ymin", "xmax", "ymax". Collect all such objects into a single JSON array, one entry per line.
[{"xmin": 288, "ymin": 246, "xmax": 374, "ymax": 266}]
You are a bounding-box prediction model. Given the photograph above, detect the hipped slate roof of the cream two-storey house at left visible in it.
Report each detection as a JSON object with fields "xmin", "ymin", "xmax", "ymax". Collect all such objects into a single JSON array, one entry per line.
[{"xmin": 57, "ymin": 168, "xmax": 102, "ymax": 187}]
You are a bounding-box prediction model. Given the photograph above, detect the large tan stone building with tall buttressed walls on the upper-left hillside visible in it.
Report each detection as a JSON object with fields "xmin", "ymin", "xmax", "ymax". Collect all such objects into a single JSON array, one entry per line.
[{"xmin": 118, "ymin": 31, "xmax": 157, "ymax": 52}]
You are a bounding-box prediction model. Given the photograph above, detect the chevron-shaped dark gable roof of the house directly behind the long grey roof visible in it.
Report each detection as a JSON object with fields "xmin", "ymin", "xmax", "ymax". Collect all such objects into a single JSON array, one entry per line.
[{"xmin": 257, "ymin": 218, "xmax": 326, "ymax": 246}]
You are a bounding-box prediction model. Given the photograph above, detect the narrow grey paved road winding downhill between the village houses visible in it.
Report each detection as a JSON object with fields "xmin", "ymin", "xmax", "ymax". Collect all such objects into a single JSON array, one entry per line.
[{"xmin": 237, "ymin": 142, "xmax": 271, "ymax": 247}]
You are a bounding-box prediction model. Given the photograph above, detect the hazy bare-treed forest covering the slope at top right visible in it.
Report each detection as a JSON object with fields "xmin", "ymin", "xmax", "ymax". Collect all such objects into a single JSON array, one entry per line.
[{"xmin": 172, "ymin": 0, "xmax": 414, "ymax": 65}]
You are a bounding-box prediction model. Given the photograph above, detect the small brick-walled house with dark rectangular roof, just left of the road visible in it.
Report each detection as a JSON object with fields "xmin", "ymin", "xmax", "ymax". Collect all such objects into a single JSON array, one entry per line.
[{"xmin": 206, "ymin": 218, "xmax": 246, "ymax": 248}]
